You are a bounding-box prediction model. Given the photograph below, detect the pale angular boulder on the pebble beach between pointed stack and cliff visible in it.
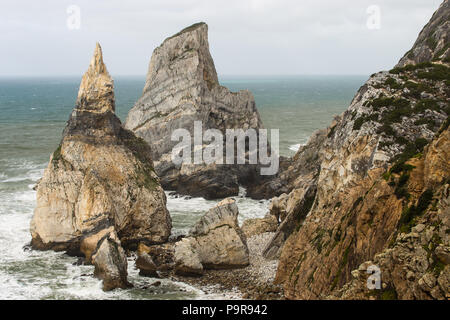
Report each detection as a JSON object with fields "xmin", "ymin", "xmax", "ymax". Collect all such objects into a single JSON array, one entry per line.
[{"xmin": 174, "ymin": 198, "xmax": 249, "ymax": 275}]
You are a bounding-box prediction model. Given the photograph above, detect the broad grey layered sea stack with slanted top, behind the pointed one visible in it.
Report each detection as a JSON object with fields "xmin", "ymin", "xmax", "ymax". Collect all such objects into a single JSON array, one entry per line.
[{"xmin": 125, "ymin": 23, "xmax": 268, "ymax": 198}]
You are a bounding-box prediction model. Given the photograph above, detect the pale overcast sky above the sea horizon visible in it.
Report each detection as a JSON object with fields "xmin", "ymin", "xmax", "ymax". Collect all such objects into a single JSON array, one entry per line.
[{"xmin": 0, "ymin": 0, "xmax": 441, "ymax": 76}]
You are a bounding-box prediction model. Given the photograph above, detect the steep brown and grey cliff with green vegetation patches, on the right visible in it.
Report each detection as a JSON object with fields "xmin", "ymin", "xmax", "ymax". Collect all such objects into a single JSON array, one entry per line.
[{"xmin": 265, "ymin": 1, "xmax": 450, "ymax": 299}]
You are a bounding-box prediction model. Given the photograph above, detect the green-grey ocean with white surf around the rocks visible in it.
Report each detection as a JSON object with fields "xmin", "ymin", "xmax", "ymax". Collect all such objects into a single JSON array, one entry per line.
[{"xmin": 0, "ymin": 75, "xmax": 367, "ymax": 299}]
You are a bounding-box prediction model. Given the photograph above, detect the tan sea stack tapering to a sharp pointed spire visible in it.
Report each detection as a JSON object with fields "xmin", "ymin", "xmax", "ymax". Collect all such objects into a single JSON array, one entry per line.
[{"xmin": 31, "ymin": 44, "xmax": 171, "ymax": 262}]
